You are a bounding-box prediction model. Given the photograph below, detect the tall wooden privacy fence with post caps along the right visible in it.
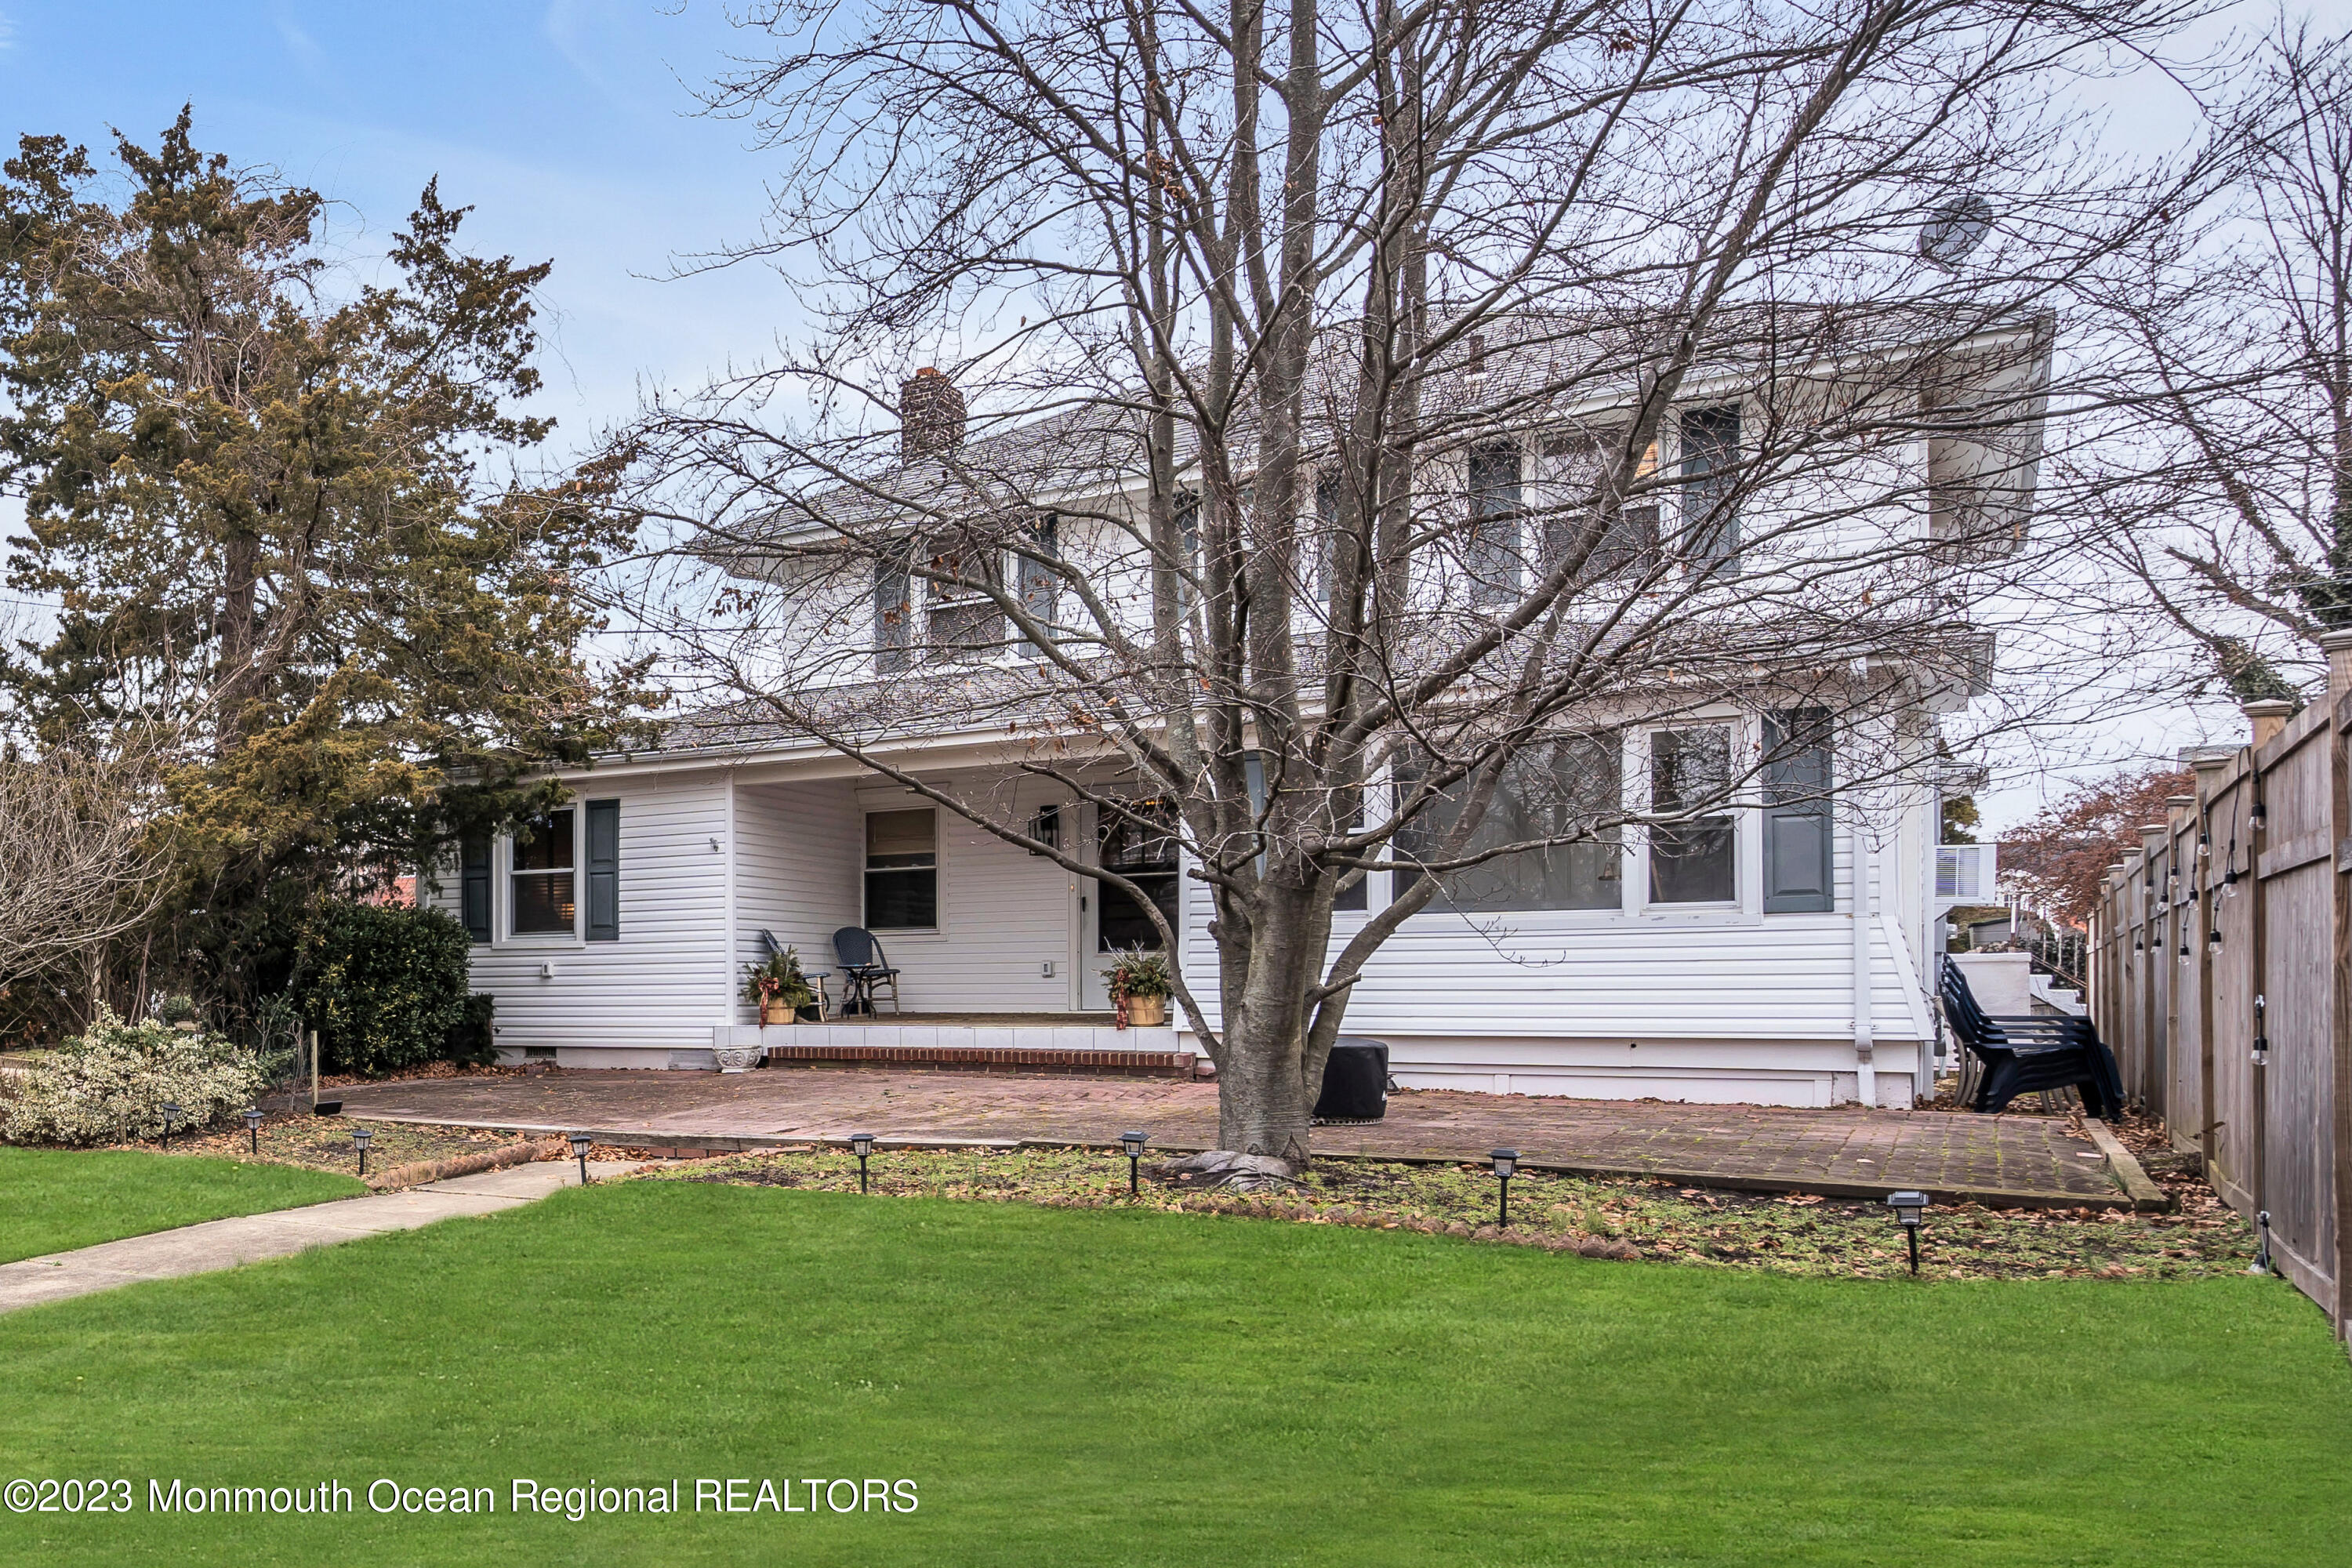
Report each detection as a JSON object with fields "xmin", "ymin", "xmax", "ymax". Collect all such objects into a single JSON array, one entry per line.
[{"xmin": 2086, "ymin": 633, "xmax": 2352, "ymax": 1338}]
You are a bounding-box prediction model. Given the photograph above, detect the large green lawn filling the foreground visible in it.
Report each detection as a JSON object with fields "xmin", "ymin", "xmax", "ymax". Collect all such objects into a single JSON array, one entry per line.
[{"xmin": 0, "ymin": 1182, "xmax": 2352, "ymax": 1568}]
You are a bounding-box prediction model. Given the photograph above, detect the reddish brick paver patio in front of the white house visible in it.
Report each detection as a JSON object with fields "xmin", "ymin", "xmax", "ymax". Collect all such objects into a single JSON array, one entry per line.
[{"xmin": 343, "ymin": 1067, "xmax": 2133, "ymax": 1208}]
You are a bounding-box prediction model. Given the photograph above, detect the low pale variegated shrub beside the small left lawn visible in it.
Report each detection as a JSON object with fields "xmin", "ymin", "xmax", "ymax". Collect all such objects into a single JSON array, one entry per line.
[{"xmin": 0, "ymin": 1011, "xmax": 268, "ymax": 1142}]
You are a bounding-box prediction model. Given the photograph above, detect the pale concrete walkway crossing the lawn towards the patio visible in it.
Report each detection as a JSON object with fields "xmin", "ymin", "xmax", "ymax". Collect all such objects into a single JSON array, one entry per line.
[{"xmin": 0, "ymin": 1159, "xmax": 637, "ymax": 1312}]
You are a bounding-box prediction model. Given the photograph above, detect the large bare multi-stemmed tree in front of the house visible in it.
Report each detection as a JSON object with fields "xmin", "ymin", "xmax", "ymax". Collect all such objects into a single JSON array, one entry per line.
[{"xmin": 626, "ymin": 0, "xmax": 2209, "ymax": 1168}]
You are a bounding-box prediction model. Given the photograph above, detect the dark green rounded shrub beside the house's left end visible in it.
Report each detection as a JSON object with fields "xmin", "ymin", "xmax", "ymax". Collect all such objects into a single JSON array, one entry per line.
[{"xmin": 296, "ymin": 902, "xmax": 468, "ymax": 1076}]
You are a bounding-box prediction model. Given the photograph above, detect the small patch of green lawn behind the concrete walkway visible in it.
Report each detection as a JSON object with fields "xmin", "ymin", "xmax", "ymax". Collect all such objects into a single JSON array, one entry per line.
[{"xmin": 0, "ymin": 1147, "xmax": 367, "ymax": 1262}]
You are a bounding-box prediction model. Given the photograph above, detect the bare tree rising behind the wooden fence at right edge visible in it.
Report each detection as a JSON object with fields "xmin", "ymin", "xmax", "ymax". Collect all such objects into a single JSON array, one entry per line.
[{"xmin": 2091, "ymin": 21, "xmax": 2352, "ymax": 701}]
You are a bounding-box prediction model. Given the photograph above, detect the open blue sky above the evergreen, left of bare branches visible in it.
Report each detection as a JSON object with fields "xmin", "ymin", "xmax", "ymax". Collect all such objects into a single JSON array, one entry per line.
[{"xmin": 0, "ymin": 0, "xmax": 793, "ymax": 449}]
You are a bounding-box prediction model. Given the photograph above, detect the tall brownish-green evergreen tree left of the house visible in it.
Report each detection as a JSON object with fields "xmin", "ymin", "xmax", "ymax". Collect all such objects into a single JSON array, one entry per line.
[{"xmin": 0, "ymin": 111, "xmax": 642, "ymax": 1020}]
